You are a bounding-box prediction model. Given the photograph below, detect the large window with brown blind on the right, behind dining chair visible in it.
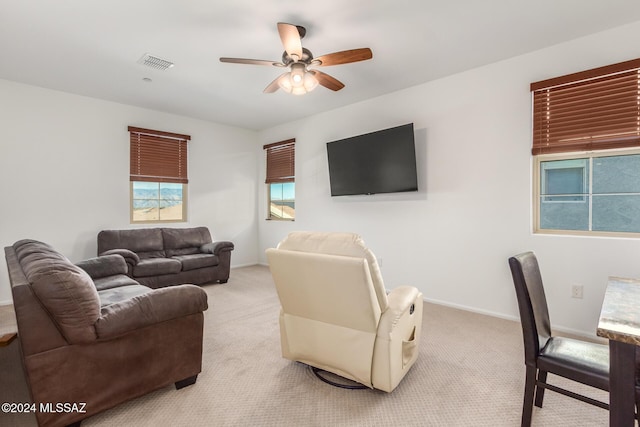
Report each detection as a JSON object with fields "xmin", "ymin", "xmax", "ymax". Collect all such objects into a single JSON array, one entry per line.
[{"xmin": 531, "ymin": 59, "xmax": 640, "ymax": 237}]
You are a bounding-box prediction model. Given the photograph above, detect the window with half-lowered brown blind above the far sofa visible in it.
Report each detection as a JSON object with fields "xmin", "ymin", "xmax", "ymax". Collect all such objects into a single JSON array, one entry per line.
[{"xmin": 129, "ymin": 126, "xmax": 191, "ymax": 223}]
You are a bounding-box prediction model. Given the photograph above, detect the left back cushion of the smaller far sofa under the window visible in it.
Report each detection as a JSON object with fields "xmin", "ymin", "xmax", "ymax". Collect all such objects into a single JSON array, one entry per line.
[{"xmin": 98, "ymin": 228, "xmax": 165, "ymax": 258}]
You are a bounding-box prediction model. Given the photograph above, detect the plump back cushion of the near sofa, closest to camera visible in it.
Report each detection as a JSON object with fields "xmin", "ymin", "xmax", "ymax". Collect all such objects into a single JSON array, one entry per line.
[{"xmin": 13, "ymin": 240, "xmax": 100, "ymax": 343}]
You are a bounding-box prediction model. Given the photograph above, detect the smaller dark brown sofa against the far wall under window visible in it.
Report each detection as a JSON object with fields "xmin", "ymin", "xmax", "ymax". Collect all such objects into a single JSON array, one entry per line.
[{"xmin": 98, "ymin": 227, "xmax": 234, "ymax": 288}]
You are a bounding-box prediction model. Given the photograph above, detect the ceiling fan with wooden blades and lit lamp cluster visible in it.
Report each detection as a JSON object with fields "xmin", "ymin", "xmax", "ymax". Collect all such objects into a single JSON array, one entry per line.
[{"xmin": 220, "ymin": 22, "xmax": 373, "ymax": 95}]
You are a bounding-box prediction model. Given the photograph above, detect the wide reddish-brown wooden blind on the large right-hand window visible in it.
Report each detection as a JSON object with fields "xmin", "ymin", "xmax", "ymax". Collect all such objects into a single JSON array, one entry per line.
[{"xmin": 531, "ymin": 59, "xmax": 640, "ymax": 155}]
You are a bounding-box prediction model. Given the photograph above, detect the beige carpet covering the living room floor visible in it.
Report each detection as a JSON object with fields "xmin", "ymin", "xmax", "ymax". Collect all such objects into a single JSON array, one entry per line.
[{"xmin": 0, "ymin": 266, "xmax": 608, "ymax": 427}]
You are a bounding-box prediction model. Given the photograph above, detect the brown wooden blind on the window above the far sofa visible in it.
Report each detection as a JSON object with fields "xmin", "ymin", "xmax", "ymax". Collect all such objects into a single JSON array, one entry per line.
[{"xmin": 129, "ymin": 126, "xmax": 191, "ymax": 184}]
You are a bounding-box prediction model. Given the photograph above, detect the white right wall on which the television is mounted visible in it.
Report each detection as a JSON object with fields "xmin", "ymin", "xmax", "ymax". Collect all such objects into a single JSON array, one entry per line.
[{"xmin": 258, "ymin": 22, "xmax": 640, "ymax": 335}]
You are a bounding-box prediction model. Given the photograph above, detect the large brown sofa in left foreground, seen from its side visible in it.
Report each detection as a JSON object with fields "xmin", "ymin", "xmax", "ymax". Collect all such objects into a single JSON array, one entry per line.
[{"xmin": 5, "ymin": 240, "xmax": 207, "ymax": 426}]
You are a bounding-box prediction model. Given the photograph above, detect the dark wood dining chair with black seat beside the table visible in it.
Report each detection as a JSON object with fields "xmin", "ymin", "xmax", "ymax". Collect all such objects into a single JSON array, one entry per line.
[{"xmin": 509, "ymin": 252, "xmax": 609, "ymax": 427}]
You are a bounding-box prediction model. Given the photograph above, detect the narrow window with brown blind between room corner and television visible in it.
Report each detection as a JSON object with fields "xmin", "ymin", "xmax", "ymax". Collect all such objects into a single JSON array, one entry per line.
[{"xmin": 263, "ymin": 139, "xmax": 296, "ymax": 221}]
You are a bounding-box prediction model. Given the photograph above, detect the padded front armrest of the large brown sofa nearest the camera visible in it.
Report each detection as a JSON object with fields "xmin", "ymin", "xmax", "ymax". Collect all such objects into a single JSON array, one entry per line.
[{"xmin": 95, "ymin": 285, "xmax": 208, "ymax": 340}]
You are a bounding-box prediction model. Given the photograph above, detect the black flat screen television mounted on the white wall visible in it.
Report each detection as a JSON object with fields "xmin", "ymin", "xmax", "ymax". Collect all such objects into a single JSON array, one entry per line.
[{"xmin": 327, "ymin": 123, "xmax": 418, "ymax": 196}]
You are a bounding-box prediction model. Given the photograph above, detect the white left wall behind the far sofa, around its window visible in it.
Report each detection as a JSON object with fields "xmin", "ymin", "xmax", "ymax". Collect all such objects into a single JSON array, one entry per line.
[{"xmin": 0, "ymin": 80, "xmax": 258, "ymax": 304}]
